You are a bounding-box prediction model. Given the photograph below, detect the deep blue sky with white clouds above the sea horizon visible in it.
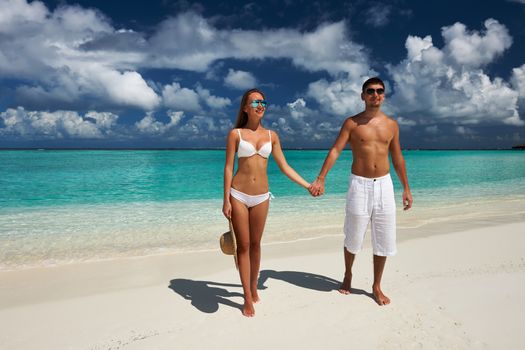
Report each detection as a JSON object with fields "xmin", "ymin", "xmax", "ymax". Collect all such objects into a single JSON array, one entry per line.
[{"xmin": 0, "ymin": 0, "xmax": 525, "ymax": 148}]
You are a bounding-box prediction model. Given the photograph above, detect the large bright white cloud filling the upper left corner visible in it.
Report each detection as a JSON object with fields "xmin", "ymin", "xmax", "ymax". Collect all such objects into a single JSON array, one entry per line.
[{"xmin": 0, "ymin": 0, "xmax": 159, "ymax": 109}]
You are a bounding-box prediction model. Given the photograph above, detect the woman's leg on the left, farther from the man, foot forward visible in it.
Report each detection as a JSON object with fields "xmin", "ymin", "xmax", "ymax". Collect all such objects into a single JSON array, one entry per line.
[{"xmin": 230, "ymin": 197, "xmax": 255, "ymax": 317}]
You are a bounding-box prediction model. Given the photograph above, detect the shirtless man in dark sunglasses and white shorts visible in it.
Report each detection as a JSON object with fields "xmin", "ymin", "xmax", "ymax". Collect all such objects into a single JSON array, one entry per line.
[{"xmin": 310, "ymin": 78, "xmax": 412, "ymax": 305}]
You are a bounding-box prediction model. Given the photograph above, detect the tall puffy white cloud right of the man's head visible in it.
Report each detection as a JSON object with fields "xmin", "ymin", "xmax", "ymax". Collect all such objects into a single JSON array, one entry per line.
[{"xmin": 388, "ymin": 20, "xmax": 525, "ymax": 125}]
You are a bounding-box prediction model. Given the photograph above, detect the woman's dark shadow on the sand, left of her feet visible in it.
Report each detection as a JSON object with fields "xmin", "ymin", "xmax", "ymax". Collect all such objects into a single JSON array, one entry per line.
[{"xmin": 168, "ymin": 278, "xmax": 243, "ymax": 313}]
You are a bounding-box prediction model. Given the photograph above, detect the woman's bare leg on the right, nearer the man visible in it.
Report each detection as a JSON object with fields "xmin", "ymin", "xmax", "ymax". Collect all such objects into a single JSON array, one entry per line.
[{"xmin": 249, "ymin": 200, "xmax": 270, "ymax": 303}]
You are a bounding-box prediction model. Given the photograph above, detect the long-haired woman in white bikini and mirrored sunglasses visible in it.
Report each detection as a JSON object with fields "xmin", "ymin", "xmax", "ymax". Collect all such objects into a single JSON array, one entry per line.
[{"xmin": 222, "ymin": 89, "xmax": 310, "ymax": 317}]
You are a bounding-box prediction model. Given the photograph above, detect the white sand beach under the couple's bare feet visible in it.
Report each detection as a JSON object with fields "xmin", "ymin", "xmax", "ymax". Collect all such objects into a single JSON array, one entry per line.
[{"xmin": 0, "ymin": 222, "xmax": 525, "ymax": 349}]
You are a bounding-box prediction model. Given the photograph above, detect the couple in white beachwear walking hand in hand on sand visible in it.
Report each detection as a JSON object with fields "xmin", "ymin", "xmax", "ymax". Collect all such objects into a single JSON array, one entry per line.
[{"xmin": 222, "ymin": 78, "xmax": 412, "ymax": 317}]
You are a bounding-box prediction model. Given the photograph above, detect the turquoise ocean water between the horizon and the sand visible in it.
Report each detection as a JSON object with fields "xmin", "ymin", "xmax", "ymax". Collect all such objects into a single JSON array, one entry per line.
[{"xmin": 0, "ymin": 150, "xmax": 525, "ymax": 269}]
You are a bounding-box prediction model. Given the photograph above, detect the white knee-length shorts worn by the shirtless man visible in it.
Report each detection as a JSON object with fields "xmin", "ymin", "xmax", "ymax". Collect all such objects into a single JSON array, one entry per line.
[{"xmin": 344, "ymin": 174, "xmax": 397, "ymax": 256}]
